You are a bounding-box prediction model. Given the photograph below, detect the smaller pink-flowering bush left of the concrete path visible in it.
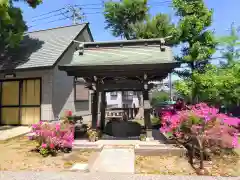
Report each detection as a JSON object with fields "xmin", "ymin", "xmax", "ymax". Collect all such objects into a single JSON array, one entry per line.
[{"xmin": 30, "ymin": 121, "xmax": 74, "ymax": 156}]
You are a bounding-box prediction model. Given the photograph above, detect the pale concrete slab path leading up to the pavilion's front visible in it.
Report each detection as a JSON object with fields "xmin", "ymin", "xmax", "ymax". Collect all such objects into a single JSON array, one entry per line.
[{"xmin": 90, "ymin": 148, "xmax": 135, "ymax": 174}]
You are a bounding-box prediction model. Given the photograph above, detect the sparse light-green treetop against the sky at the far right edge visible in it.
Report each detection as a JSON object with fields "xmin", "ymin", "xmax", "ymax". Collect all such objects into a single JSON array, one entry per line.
[{"xmin": 217, "ymin": 23, "xmax": 240, "ymax": 66}]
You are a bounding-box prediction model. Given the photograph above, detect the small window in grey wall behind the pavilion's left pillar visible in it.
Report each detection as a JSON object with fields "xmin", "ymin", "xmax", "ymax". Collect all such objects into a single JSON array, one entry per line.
[{"xmin": 74, "ymin": 80, "xmax": 89, "ymax": 101}]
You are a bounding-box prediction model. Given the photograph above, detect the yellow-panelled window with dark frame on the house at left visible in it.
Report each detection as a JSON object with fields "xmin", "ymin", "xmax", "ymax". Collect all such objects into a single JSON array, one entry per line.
[{"xmin": 0, "ymin": 78, "xmax": 41, "ymax": 125}]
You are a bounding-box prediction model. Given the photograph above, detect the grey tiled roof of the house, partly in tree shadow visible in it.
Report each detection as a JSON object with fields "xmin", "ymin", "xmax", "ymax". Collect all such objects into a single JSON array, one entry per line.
[{"xmin": 0, "ymin": 24, "xmax": 87, "ymax": 70}]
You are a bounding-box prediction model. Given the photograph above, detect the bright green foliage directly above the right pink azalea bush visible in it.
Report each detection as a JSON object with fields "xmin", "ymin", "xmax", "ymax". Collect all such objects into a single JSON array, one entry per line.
[{"xmin": 194, "ymin": 62, "xmax": 240, "ymax": 105}]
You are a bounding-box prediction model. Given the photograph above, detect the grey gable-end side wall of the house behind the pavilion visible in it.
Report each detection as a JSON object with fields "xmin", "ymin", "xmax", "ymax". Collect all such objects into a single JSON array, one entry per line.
[{"xmin": 53, "ymin": 27, "xmax": 91, "ymax": 118}]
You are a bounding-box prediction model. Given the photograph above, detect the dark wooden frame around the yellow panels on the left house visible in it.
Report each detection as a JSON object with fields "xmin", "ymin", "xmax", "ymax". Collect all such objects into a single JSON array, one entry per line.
[{"xmin": 0, "ymin": 77, "xmax": 42, "ymax": 126}]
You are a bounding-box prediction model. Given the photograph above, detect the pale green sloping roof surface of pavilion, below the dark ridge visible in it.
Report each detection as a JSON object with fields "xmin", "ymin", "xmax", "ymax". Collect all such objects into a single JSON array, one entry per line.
[{"xmin": 71, "ymin": 46, "xmax": 174, "ymax": 66}]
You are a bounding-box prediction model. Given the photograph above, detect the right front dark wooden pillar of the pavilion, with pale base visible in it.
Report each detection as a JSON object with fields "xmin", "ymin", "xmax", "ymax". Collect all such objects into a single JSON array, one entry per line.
[{"xmin": 143, "ymin": 89, "xmax": 153, "ymax": 140}]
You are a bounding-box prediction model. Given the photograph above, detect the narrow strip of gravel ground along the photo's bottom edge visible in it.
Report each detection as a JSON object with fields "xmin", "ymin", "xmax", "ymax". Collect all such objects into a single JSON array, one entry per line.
[{"xmin": 0, "ymin": 171, "xmax": 240, "ymax": 180}]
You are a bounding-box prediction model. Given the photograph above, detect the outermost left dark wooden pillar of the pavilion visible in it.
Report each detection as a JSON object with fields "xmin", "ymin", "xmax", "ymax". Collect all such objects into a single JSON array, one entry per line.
[{"xmin": 91, "ymin": 90, "xmax": 99, "ymax": 129}]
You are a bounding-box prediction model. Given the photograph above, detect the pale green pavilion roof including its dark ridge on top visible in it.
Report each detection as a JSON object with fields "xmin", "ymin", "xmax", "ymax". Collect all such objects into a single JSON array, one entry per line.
[{"xmin": 67, "ymin": 41, "xmax": 174, "ymax": 66}]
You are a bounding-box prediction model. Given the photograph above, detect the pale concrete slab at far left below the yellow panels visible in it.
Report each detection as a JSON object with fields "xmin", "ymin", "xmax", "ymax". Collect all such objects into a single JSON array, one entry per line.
[{"xmin": 0, "ymin": 126, "xmax": 31, "ymax": 141}]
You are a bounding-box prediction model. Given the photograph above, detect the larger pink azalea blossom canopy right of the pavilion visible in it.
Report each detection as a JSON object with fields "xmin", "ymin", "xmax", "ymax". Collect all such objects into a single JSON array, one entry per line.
[{"xmin": 160, "ymin": 103, "xmax": 240, "ymax": 148}]
